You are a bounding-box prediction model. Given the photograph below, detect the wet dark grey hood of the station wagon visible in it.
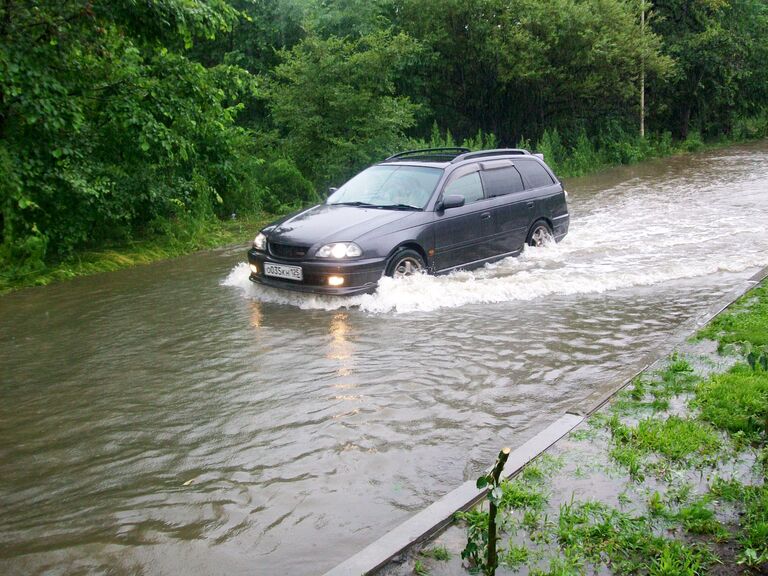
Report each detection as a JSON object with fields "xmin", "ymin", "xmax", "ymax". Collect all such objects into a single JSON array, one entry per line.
[{"xmin": 265, "ymin": 204, "xmax": 414, "ymax": 246}]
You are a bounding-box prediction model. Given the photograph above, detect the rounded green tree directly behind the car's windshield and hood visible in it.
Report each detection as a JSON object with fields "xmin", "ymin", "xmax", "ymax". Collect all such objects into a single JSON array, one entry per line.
[{"xmin": 266, "ymin": 32, "xmax": 418, "ymax": 185}]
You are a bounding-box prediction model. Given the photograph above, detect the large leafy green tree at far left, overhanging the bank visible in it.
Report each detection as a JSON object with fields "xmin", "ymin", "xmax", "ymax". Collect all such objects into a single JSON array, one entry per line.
[{"xmin": 0, "ymin": 0, "xmax": 255, "ymax": 269}]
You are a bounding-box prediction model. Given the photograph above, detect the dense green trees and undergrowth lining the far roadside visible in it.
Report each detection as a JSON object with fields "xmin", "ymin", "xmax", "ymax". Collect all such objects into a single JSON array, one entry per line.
[{"xmin": 0, "ymin": 0, "xmax": 768, "ymax": 275}]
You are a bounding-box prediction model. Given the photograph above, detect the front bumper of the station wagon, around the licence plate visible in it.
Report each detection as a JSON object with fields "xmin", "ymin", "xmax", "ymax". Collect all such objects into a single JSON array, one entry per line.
[{"xmin": 248, "ymin": 248, "xmax": 386, "ymax": 296}]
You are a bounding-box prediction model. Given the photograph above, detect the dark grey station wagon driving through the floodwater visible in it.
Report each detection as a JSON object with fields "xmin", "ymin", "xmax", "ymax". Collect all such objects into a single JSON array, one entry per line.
[{"xmin": 248, "ymin": 148, "xmax": 569, "ymax": 295}]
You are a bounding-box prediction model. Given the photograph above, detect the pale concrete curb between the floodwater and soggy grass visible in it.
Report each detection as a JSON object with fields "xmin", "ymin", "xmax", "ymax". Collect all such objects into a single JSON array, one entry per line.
[{"xmin": 324, "ymin": 266, "xmax": 768, "ymax": 576}]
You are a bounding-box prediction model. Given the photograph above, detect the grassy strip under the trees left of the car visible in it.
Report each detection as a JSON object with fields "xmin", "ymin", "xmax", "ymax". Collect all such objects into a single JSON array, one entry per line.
[{"xmin": 0, "ymin": 213, "xmax": 275, "ymax": 295}]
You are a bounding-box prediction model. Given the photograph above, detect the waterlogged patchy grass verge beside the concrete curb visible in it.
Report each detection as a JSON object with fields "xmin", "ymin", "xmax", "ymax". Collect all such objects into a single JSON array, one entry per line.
[{"xmin": 383, "ymin": 281, "xmax": 768, "ymax": 576}]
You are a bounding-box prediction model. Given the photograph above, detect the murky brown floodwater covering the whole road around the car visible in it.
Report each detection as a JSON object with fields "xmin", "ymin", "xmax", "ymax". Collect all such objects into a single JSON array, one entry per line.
[{"xmin": 0, "ymin": 142, "xmax": 768, "ymax": 575}]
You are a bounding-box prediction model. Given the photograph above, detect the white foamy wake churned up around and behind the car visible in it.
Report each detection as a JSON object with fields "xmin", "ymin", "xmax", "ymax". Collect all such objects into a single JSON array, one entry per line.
[{"xmin": 223, "ymin": 163, "xmax": 768, "ymax": 313}]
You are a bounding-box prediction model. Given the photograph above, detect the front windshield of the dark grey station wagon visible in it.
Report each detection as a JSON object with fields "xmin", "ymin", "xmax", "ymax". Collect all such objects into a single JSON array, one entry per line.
[{"xmin": 328, "ymin": 166, "xmax": 443, "ymax": 210}]
